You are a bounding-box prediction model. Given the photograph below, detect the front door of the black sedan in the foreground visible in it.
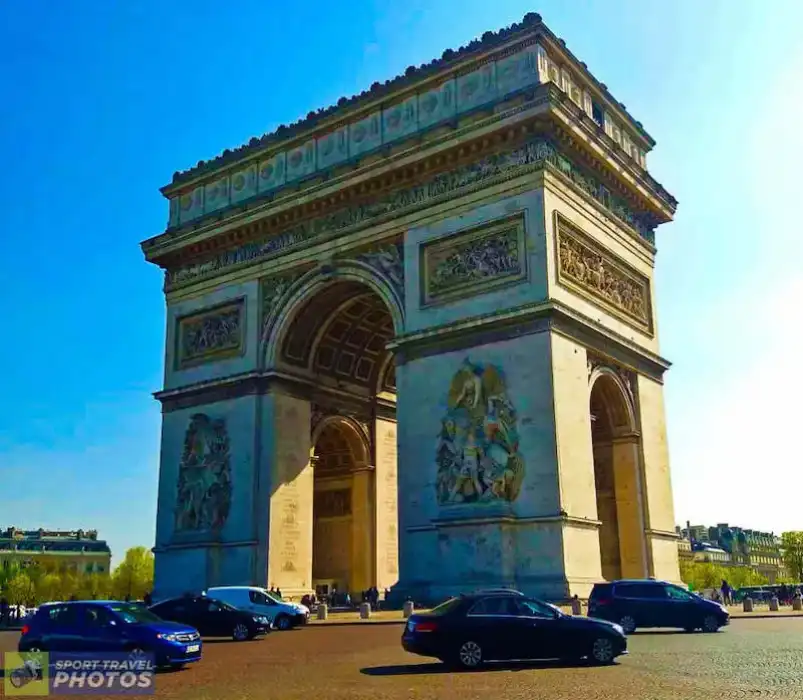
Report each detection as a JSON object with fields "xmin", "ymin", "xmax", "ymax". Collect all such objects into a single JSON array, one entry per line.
[{"xmin": 509, "ymin": 598, "xmax": 569, "ymax": 659}]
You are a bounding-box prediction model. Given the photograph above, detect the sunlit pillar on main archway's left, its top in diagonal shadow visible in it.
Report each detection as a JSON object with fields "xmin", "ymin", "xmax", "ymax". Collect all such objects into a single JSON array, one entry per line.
[{"xmin": 264, "ymin": 393, "xmax": 313, "ymax": 596}]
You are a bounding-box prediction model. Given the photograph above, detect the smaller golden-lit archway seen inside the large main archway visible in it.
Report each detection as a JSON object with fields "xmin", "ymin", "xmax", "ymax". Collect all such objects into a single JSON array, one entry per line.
[{"xmin": 312, "ymin": 416, "xmax": 376, "ymax": 595}]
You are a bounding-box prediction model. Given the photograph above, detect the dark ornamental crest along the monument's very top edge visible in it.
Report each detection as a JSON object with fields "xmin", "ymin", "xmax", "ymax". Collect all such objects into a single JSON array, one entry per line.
[{"xmin": 162, "ymin": 12, "xmax": 655, "ymax": 193}]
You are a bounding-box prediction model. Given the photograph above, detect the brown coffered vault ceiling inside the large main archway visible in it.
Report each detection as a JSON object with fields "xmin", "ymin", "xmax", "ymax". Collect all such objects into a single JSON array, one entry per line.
[{"xmin": 281, "ymin": 281, "xmax": 396, "ymax": 393}]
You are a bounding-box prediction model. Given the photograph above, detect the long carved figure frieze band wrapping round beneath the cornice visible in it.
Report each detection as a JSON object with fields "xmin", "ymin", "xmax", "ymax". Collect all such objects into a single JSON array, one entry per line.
[{"xmin": 165, "ymin": 138, "xmax": 654, "ymax": 290}]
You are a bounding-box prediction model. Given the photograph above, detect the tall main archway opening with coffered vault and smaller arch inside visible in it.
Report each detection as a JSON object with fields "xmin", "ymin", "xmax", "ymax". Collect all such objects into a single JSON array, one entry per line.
[{"xmin": 274, "ymin": 277, "xmax": 398, "ymax": 595}]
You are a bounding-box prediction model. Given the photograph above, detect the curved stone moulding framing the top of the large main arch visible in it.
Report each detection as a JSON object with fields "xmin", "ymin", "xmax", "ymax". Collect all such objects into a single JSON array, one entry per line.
[{"xmin": 260, "ymin": 259, "xmax": 404, "ymax": 368}]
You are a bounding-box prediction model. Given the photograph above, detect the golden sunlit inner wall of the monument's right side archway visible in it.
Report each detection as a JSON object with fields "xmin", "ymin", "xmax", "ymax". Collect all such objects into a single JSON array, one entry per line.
[{"xmin": 612, "ymin": 435, "xmax": 649, "ymax": 578}]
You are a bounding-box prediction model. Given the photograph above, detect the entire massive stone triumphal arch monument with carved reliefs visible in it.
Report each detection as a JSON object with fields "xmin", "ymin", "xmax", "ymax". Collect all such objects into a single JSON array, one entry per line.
[{"xmin": 143, "ymin": 15, "xmax": 679, "ymax": 600}]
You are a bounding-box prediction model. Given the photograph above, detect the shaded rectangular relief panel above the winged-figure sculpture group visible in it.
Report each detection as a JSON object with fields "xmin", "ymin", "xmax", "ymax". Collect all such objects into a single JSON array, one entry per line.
[{"xmin": 421, "ymin": 214, "xmax": 527, "ymax": 305}]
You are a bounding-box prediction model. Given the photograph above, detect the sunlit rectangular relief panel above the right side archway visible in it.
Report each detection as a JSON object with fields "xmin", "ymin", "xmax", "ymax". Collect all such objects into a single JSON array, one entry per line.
[{"xmin": 555, "ymin": 212, "xmax": 653, "ymax": 335}]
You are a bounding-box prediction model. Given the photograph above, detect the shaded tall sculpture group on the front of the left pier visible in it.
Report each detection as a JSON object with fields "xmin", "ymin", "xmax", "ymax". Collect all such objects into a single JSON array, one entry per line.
[{"xmin": 175, "ymin": 413, "xmax": 232, "ymax": 532}]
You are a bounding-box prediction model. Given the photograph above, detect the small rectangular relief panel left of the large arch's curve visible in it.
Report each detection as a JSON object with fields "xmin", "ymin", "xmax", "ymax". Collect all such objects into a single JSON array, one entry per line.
[{"xmin": 176, "ymin": 299, "xmax": 245, "ymax": 369}]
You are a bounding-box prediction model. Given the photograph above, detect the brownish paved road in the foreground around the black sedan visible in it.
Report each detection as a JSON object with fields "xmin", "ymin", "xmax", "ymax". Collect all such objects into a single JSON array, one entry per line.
[{"xmin": 0, "ymin": 618, "xmax": 803, "ymax": 700}]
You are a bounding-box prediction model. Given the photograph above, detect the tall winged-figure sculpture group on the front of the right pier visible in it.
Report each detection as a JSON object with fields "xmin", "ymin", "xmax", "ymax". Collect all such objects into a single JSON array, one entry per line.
[{"xmin": 435, "ymin": 358, "xmax": 525, "ymax": 505}]
